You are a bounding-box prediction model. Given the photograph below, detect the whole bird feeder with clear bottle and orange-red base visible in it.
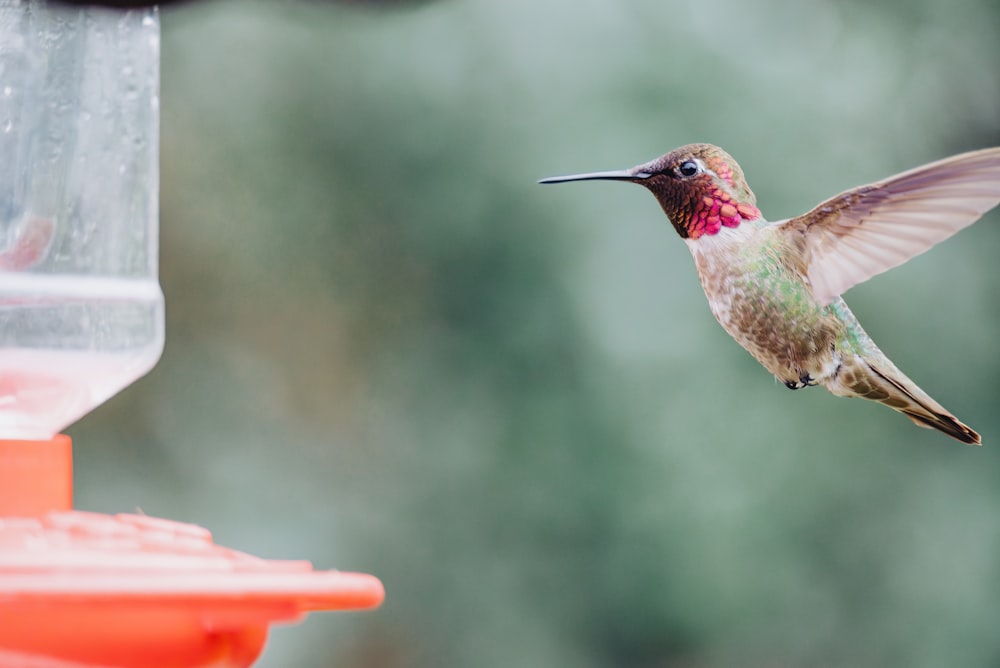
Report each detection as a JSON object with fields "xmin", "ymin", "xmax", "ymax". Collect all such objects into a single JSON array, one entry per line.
[{"xmin": 0, "ymin": 0, "xmax": 383, "ymax": 668}]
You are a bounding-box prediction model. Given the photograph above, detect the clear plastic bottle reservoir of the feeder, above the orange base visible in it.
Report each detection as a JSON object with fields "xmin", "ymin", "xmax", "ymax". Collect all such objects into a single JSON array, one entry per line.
[{"xmin": 0, "ymin": 0, "xmax": 163, "ymax": 439}]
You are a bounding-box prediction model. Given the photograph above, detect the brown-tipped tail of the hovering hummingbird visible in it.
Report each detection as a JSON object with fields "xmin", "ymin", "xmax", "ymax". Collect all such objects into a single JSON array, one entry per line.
[{"xmin": 831, "ymin": 357, "xmax": 982, "ymax": 445}]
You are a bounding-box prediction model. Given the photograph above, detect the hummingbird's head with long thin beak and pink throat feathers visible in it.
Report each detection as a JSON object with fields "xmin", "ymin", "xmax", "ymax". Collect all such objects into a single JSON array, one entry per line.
[{"xmin": 540, "ymin": 144, "xmax": 760, "ymax": 239}]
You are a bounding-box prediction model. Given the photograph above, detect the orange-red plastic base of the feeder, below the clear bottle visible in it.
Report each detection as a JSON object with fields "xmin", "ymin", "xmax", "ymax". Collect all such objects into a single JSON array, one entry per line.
[{"xmin": 0, "ymin": 436, "xmax": 385, "ymax": 668}]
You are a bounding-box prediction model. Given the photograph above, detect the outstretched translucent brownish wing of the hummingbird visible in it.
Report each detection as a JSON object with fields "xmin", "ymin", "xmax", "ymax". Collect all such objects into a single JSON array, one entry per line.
[{"xmin": 782, "ymin": 147, "xmax": 1000, "ymax": 304}]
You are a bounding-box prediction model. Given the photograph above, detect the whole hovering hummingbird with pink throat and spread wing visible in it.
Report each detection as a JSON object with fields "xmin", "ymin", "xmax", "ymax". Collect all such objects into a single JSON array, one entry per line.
[{"xmin": 539, "ymin": 144, "xmax": 1000, "ymax": 445}]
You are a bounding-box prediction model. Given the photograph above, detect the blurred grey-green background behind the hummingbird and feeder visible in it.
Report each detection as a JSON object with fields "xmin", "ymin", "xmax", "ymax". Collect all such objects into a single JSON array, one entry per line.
[{"xmin": 69, "ymin": 0, "xmax": 1000, "ymax": 668}]
